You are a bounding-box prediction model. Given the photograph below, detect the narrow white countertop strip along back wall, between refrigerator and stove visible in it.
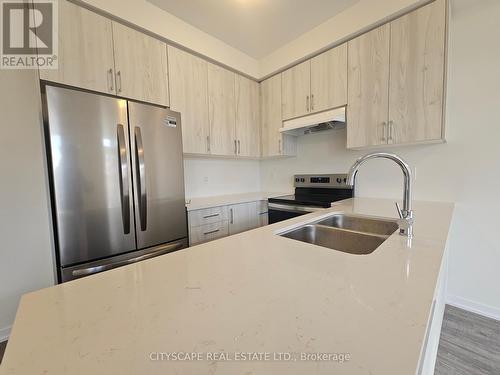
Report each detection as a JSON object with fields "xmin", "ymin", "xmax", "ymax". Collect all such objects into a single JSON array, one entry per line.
[{"xmin": 186, "ymin": 191, "xmax": 291, "ymax": 211}]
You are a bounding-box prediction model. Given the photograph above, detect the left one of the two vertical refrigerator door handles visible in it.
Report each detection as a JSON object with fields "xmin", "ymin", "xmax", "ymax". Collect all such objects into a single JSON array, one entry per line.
[{"xmin": 116, "ymin": 124, "xmax": 130, "ymax": 234}]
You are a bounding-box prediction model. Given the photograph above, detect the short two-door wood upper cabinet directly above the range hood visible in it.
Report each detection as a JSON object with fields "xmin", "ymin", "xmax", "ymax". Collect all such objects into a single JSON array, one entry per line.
[{"xmin": 281, "ymin": 44, "xmax": 347, "ymax": 120}]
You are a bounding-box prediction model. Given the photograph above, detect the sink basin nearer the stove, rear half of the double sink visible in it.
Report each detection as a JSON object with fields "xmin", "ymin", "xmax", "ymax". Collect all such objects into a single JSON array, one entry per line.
[{"xmin": 315, "ymin": 214, "xmax": 398, "ymax": 236}]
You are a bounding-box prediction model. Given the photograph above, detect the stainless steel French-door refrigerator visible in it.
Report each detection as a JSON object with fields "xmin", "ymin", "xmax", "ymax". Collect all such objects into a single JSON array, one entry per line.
[{"xmin": 42, "ymin": 85, "xmax": 188, "ymax": 282}]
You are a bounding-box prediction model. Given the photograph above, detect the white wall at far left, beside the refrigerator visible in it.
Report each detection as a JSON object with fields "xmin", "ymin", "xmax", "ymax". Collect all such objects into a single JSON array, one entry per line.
[{"xmin": 0, "ymin": 70, "xmax": 54, "ymax": 341}]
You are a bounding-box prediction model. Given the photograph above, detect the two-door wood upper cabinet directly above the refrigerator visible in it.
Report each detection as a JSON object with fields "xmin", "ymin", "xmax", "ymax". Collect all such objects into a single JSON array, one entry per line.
[{"xmin": 40, "ymin": 0, "xmax": 169, "ymax": 106}]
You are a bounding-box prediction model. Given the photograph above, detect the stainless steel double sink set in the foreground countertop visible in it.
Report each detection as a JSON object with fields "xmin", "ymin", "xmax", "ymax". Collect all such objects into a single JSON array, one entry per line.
[{"xmin": 280, "ymin": 214, "xmax": 399, "ymax": 255}]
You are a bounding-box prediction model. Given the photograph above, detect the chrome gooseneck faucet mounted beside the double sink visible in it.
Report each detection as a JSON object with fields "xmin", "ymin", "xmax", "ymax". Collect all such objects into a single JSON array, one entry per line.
[{"xmin": 347, "ymin": 152, "xmax": 413, "ymax": 238}]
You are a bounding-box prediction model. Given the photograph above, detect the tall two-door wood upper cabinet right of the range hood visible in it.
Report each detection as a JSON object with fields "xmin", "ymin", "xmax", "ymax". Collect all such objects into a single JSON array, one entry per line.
[{"xmin": 347, "ymin": 0, "xmax": 446, "ymax": 148}]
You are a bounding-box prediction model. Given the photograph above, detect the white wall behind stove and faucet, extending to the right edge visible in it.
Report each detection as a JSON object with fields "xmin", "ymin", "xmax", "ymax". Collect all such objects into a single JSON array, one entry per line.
[{"xmin": 261, "ymin": 0, "xmax": 500, "ymax": 317}]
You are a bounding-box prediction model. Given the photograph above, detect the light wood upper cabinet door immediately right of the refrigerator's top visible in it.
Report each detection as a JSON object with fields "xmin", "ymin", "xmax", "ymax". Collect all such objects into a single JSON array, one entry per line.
[{"xmin": 168, "ymin": 46, "xmax": 210, "ymax": 154}]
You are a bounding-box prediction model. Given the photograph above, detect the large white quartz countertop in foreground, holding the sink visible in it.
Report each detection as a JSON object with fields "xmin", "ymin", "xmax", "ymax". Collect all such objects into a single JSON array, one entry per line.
[{"xmin": 0, "ymin": 198, "xmax": 453, "ymax": 375}]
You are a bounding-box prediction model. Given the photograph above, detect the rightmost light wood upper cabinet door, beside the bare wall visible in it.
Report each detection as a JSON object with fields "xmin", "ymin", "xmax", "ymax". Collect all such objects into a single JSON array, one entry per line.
[{"xmin": 389, "ymin": 0, "xmax": 446, "ymax": 143}]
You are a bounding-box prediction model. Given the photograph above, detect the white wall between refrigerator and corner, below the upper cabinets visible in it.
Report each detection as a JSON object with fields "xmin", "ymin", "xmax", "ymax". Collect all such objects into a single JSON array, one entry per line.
[{"xmin": 184, "ymin": 158, "xmax": 260, "ymax": 199}]
